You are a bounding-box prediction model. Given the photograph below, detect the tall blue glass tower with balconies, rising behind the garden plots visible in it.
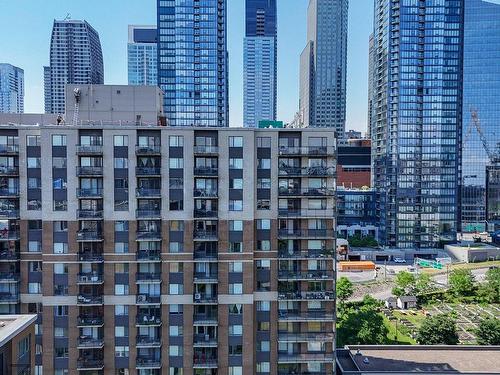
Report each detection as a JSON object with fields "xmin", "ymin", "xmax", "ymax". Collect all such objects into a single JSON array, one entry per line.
[{"xmin": 371, "ymin": 0, "xmax": 464, "ymax": 249}]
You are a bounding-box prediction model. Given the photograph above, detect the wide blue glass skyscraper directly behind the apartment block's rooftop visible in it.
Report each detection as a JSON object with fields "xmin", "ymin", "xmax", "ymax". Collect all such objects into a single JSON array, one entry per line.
[{"xmin": 157, "ymin": 0, "xmax": 229, "ymax": 127}]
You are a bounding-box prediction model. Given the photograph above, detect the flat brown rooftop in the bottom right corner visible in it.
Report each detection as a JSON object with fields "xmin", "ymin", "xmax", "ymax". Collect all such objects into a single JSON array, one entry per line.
[{"xmin": 337, "ymin": 345, "xmax": 500, "ymax": 374}]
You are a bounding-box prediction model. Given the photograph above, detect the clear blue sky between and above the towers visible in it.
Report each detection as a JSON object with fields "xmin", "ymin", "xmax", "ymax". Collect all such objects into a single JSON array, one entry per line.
[{"xmin": 0, "ymin": 0, "xmax": 373, "ymax": 131}]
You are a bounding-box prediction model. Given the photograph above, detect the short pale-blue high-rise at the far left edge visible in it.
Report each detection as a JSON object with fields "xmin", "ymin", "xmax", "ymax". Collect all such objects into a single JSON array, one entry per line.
[{"xmin": 0, "ymin": 63, "xmax": 24, "ymax": 113}]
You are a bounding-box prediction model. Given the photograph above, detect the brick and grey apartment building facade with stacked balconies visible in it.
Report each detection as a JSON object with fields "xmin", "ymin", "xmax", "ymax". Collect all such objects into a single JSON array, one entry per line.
[{"xmin": 0, "ymin": 125, "xmax": 336, "ymax": 375}]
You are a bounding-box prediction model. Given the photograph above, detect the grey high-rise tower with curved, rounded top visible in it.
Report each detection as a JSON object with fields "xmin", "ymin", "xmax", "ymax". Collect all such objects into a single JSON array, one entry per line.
[{"xmin": 44, "ymin": 19, "xmax": 104, "ymax": 113}]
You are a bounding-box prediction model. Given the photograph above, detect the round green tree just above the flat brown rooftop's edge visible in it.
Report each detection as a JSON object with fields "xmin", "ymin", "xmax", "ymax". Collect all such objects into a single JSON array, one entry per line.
[{"xmin": 417, "ymin": 314, "xmax": 458, "ymax": 345}]
